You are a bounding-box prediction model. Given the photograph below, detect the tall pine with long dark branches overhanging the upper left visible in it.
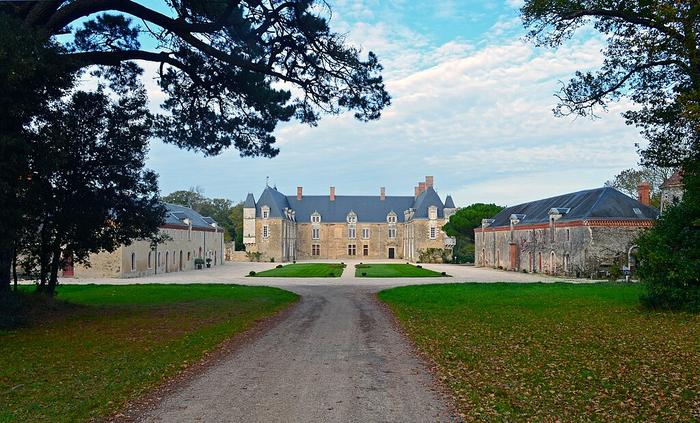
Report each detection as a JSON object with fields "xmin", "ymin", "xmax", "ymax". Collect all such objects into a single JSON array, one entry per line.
[{"xmin": 0, "ymin": 0, "xmax": 390, "ymax": 290}]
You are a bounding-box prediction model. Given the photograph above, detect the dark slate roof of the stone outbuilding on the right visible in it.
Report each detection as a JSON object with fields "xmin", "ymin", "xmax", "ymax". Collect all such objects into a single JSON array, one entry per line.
[{"xmin": 490, "ymin": 187, "xmax": 659, "ymax": 227}]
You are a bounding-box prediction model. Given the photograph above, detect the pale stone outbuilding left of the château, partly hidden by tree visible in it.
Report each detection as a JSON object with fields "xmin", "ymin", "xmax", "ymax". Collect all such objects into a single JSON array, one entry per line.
[{"xmin": 63, "ymin": 204, "xmax": 224, "ymax": 278}]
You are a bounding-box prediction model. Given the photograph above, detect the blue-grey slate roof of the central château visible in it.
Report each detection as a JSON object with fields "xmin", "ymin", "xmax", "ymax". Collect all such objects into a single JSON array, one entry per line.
[{"xmin": 252, "ymin": 187, "xmax": 444, "ymax": 223}]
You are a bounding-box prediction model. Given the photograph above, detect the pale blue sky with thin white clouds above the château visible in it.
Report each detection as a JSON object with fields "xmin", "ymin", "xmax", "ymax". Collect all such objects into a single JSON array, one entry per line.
[{"xmin": 133, "ymin": 0, "xmax": 641, "ymax": 207}]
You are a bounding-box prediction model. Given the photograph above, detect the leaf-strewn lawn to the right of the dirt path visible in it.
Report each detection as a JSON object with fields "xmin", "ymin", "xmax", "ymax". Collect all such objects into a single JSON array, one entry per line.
[{"xmin": 379, "ymin": 284, "xmax": 700, "ymax": 422}]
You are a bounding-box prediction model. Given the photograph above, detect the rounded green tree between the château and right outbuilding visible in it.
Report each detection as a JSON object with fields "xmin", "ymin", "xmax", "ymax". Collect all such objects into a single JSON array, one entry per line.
[{"xmin": 442, "ymin": 203, "xmax": 503, "ymax": 263}]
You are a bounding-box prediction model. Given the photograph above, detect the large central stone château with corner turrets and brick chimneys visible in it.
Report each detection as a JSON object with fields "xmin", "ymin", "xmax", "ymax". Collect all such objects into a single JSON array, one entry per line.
[{"xmin": 243, "ymin": 176, "xmax": 457, "ymax": 261}]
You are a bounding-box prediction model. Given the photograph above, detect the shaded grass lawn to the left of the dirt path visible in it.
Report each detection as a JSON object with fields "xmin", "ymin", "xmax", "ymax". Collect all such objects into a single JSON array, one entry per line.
[{"xmin": 0, "ymin": 284, "xmax": 298, "ymax": 422}]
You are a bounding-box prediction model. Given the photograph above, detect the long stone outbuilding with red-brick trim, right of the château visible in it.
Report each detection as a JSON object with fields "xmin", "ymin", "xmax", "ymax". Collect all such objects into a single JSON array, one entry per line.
[{"xmin": 474, "ymin": 186, "xmax": 658, "ymax": 277}]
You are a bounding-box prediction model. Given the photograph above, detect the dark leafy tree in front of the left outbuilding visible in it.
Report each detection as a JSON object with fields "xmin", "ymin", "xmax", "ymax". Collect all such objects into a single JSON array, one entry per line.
[{"xmin": 25, "ymin": 89, "xmax": 164, "ymax": 294}]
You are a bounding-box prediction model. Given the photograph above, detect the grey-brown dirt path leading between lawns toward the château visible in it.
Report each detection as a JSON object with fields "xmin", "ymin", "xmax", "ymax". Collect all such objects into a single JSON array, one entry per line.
[{"xmin": 141, "ymin": 285, "xmax": 452, "ymax": 422}]
